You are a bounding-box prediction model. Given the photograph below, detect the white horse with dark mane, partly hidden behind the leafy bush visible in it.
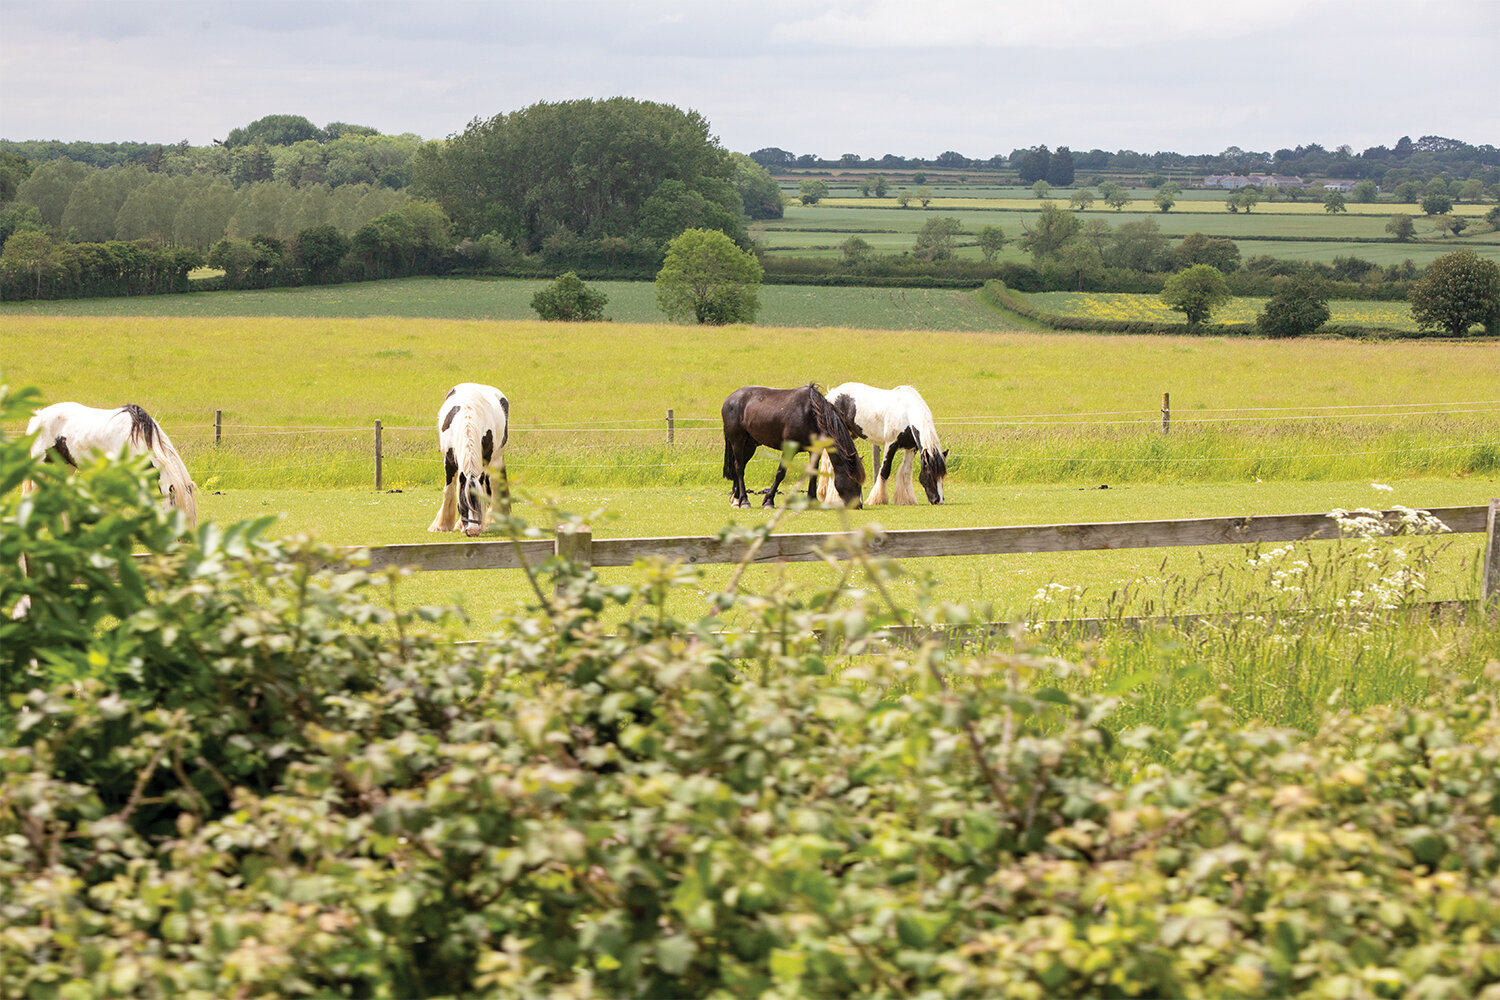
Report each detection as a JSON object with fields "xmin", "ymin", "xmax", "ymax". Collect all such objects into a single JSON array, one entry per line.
[{"xmin": 26, "ymin": 403, "xmax": 198, "ymax": 528}]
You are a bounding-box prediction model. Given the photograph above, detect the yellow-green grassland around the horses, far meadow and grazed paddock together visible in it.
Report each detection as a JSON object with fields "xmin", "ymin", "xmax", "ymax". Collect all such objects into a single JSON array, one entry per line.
[{"xmin": 0, "ymin": 305, "xmax": 1500, "ymax": 711}]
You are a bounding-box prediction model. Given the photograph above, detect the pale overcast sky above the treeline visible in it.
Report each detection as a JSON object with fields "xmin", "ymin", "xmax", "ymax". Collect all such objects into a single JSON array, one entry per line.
[{"xmin": 0, "ymin": 0, "xmax": 1500, "ymax": 157}]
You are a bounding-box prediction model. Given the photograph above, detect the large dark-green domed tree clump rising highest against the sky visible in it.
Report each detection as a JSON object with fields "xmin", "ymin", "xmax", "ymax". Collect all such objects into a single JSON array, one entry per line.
[{"xmin": 413, "ymin": 97, "xmax": 747, "ymax": 250}]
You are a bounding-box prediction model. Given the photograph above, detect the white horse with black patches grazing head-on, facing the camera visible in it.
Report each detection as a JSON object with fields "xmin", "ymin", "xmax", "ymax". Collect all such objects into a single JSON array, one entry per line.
[{"xmin": 428, "ymin": 382, "xmax": 510, "ymax": 538}]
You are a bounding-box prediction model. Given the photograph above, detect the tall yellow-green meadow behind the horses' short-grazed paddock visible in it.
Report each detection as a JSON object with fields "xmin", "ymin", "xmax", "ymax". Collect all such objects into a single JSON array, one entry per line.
[{"xmin": 0, "ymin": 313, "xmax": 1500, "ymax": 487}]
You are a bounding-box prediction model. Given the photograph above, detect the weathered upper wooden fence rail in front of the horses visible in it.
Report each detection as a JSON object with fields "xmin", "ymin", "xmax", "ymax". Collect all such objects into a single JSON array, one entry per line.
[{"xmin": 360, "ymin": 499, "xmax": 1500, "ymax": 603}]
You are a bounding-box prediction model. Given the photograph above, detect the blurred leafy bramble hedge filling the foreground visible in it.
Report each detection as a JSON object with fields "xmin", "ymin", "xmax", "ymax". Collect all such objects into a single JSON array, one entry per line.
[{"xmin": 0, "ymin": 379, "xmax": 1500, "ymax": 999}]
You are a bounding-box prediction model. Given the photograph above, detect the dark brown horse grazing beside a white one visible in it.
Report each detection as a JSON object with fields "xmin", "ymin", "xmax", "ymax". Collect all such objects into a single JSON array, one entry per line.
[{"xmin": 723, "ymin": 385, "xmax": 864, "ymax": 507}]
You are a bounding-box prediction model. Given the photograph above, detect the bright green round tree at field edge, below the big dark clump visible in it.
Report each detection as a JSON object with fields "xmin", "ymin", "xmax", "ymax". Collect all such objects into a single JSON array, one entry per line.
[{"xmin": 656, "ymin": 229, "xmax": 765, "ymax": 327}]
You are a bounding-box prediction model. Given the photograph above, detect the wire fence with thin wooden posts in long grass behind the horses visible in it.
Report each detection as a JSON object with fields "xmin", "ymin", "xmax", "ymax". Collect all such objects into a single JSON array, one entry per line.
[{"xmin": 152, "ymin": 394, "xmax": 1500, "ymax": 487}]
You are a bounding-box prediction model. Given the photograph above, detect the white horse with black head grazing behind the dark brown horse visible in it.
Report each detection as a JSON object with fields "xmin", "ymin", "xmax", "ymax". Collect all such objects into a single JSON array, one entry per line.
[{"xmin": 819, "ymin": 382, "xmax": 948, "ymax": 507}]
